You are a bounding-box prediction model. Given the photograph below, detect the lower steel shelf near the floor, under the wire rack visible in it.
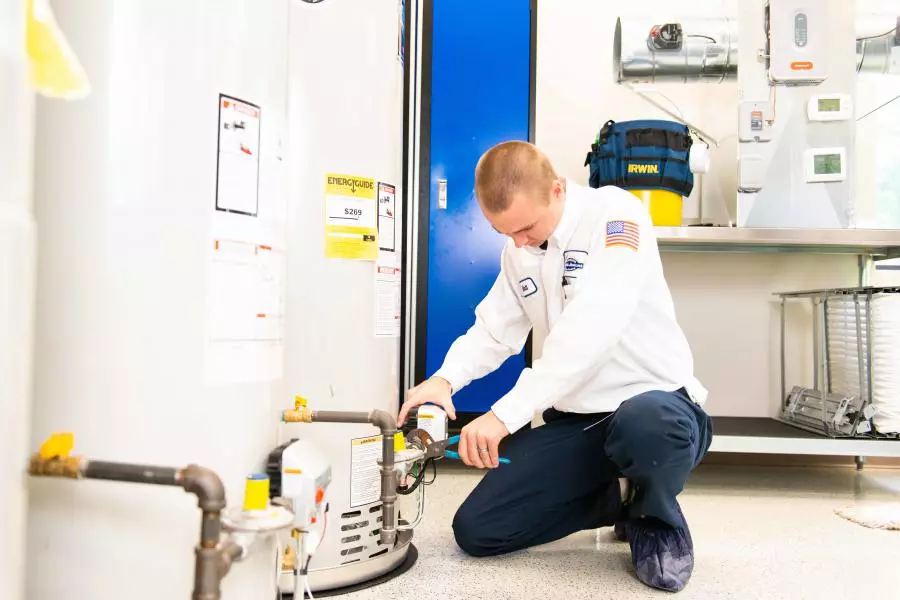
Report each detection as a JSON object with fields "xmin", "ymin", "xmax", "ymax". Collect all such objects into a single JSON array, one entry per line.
[{"xmin": 709, "ymin": 417, "xmax": 900, "ymax": 457}]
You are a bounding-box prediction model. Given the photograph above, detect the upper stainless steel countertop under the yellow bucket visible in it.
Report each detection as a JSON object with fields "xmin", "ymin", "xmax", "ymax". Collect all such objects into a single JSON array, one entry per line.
[{"xmin": 655, "ymin": 227, "xmax": 900, "ymax": 258}]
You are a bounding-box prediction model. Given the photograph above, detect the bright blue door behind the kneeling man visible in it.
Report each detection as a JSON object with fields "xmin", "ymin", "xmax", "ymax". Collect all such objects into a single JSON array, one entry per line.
[{"xmin": 417, "ymin": 0, "xmax": 533, "ymax": 413}]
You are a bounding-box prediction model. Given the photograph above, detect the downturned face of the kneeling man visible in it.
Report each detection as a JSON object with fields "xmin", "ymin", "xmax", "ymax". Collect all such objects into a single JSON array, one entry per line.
[{"xmin": 482, "ymin": 182, "xmax": 562, "ymax": 248}]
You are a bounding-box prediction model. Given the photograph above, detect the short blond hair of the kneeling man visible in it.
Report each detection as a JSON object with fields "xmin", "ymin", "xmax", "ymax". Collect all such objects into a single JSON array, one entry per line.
[{"xmin": 475, "ymin": 141, "xmax": 557, "ymax": 213}]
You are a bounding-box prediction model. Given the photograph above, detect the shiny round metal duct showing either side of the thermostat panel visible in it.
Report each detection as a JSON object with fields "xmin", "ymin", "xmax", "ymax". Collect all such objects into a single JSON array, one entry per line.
[{"xmin": 613, "ymin": 17, "xmax": 897, "ymax": 83}]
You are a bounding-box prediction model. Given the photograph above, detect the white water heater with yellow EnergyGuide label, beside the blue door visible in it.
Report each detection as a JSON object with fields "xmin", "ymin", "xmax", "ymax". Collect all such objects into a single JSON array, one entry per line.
[{"xmin": 281, "ymin": 0, "xmax": 415, "ymax": 593}]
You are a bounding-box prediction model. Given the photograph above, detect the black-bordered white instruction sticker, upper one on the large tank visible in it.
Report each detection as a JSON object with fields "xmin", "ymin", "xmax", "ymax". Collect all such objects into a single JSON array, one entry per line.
[{"xmin": 216, "ymin": 94, "xmax": 260, "ymax": 217}]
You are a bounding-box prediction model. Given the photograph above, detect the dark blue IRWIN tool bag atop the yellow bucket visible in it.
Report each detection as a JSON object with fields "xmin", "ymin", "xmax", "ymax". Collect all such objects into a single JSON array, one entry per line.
[{"xmin": 584, "ymin": 120, "xmax": 694, "ymax": 196}]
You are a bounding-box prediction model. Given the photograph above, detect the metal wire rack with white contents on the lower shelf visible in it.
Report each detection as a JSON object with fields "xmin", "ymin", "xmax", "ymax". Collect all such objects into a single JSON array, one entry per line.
[{"xmin": 777, "ymin": 287, "xmax": 900, "ymax": 438}]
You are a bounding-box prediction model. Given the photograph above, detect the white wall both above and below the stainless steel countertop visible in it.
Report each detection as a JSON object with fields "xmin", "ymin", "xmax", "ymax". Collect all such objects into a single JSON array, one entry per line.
[{"xmin": 536, "ymin": 0, "xmax": 889, "ymax": 416}]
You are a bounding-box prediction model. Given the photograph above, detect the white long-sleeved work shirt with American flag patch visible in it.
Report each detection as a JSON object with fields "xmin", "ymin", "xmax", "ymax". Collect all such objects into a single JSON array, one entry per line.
[{"xmin": 435, "ymin": 181, "xmax": 707, "ymax": 433}]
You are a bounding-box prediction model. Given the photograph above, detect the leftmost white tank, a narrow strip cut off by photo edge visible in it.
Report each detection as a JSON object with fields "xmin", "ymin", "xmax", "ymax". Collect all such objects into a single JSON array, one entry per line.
[{"xmin": 0, "ymin": 0, "xmax": 35, "ymax": 600}]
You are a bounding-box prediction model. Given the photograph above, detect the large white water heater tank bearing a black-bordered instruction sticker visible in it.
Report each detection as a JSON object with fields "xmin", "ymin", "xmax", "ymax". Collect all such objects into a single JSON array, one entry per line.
[{"xmin": 27, "ymin": 0, "xmax": 289, "ymax": 600}]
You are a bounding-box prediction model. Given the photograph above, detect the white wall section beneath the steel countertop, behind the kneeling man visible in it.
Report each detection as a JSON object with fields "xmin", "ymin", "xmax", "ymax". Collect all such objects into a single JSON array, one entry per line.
[{"xmin": 663, "ymin": 253, "xmax": 857, "ymax": 417}]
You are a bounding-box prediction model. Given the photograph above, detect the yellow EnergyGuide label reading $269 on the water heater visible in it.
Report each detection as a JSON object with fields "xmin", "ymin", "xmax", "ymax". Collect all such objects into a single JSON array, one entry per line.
[{"xmin": 325, "ymin": 174, "xmax": 378, "ymax": 260}]
